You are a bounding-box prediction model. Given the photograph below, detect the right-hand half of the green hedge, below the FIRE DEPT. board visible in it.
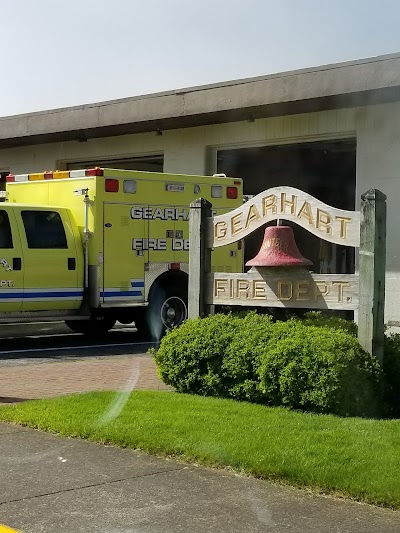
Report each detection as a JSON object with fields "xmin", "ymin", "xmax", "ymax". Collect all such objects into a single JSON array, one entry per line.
[{"xmin": 259, "ymin": 320, "xmax": 381, "ymax": 416}]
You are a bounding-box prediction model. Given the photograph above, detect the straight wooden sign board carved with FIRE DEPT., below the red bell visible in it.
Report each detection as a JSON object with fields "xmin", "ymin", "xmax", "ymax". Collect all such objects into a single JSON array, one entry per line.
[{"xmin": 205, "ymin": 268, "xmax": 359, "ymax": 309}]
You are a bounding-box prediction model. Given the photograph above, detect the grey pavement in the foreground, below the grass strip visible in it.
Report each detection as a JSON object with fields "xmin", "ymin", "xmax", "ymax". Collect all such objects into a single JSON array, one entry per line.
[{"xmin": 0, "ymin": 424, "xmax": 400, "ymax": 533}]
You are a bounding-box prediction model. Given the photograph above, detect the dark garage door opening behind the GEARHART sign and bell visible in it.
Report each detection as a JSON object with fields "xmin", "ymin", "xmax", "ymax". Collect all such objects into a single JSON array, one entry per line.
[{"xmin": 217, "ymin": 139, "xmax": 356, "ymax": 274}]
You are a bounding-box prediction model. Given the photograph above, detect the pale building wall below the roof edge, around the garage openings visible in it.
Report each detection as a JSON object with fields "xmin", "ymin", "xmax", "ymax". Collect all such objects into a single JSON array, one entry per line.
[{"xmin": 0, "ymin": 103, "xmax": 400, "ymax": 323}]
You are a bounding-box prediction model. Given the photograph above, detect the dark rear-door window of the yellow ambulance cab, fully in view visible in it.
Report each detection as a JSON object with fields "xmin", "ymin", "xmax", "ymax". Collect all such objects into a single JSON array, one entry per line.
[{"xmin": 21, "ymin": 211, "xmax": 68, "ymax": 248}]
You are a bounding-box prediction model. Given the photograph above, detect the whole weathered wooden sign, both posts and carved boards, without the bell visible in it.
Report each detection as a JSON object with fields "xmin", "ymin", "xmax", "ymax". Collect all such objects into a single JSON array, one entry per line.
[{"xmin": 189, "ymin": 187, "xmax": 386, "ymax": 363}]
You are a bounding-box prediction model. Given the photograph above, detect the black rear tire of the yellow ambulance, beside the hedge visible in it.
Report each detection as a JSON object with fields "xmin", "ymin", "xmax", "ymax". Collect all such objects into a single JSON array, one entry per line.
[{"xmin": 135, "ymin": 286, "xmax": 187, "ymax": 341}]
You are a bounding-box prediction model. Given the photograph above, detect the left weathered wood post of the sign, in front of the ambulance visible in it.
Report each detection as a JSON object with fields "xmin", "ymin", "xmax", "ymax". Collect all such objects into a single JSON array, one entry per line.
[{"xmin": 188, "ymin": 198, "xmax": 211, "ymax": 318}]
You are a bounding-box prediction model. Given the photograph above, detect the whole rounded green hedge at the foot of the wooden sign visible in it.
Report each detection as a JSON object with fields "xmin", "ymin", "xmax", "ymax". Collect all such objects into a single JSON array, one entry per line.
[{"xmin": 155, "ymin": 312, "xmax": 390, "ymax": 416}]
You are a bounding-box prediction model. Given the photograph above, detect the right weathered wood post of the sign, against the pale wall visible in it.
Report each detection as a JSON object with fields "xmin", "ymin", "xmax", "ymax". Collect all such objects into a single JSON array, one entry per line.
[{"xmin": 358, "ymin": 189, "xmax": 386, "ymax": 364}]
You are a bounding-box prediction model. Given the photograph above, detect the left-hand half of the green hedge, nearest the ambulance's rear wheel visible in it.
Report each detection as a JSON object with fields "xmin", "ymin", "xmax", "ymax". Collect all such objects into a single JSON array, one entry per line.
[{"xmin": 155, "ymin": 313, "xmax": 272, "ymax": 401}]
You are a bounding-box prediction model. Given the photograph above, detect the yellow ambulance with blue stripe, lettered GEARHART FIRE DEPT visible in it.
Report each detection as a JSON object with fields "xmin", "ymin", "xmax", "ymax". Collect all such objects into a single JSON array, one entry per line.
[{"xmin": 0, "ymin": 168, "xmax": 243, "ymax": 339}]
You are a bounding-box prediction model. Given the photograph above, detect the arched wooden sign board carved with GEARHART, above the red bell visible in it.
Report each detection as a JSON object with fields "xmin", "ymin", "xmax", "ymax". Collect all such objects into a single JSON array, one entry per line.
[{"xmin": 211, "ymin": 187, "xmax": 360, "ymax": 248}]
